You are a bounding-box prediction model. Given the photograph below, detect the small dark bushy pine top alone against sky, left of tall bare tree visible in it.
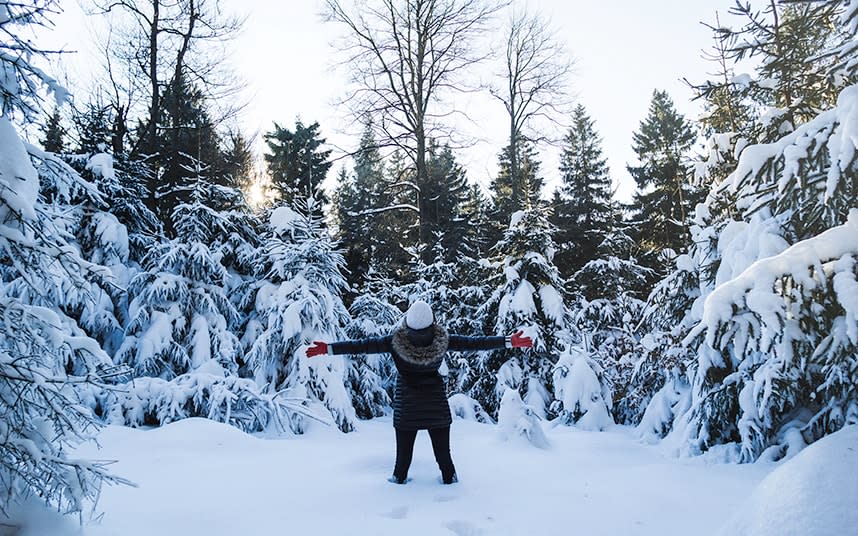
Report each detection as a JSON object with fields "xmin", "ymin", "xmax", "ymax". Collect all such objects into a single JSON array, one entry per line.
[{"xmin": 263, "ymin": 119, "xmax": 331, "ymax": 218}]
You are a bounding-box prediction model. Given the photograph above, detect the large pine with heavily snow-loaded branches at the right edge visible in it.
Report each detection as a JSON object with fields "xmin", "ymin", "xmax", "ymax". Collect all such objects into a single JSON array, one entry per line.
[{"xmin": 654, "ymin": 1, "xmax": 858, "ymax": 461}]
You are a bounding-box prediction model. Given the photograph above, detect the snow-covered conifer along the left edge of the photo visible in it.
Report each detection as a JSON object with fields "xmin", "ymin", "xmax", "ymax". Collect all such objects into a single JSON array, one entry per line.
[{"xmin": 0, "ymin": 2, "xmax": 130, "ymax": 513}]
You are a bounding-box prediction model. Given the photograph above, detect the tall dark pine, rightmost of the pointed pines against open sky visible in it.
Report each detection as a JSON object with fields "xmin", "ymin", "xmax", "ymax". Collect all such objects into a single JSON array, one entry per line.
[{"xmin": 628, "ymin": 90, "xmax": 699, "ymax": 268}]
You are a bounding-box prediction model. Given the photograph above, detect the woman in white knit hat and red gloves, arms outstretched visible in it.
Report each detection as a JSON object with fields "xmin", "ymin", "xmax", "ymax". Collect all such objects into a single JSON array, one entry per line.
[{"xmin": 300, "ymin": 301, "xmax": 532, "ymax": 484}]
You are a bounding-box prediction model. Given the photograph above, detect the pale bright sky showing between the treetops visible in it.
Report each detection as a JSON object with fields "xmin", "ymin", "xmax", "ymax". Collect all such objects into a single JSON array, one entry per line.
[{"xmin": 45, "ymin": 0, "xmax": 716, "ymax": 200}]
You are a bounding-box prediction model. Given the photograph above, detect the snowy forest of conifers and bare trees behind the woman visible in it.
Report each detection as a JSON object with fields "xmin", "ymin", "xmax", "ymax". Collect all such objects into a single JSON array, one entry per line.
[{"xmin": 0, "ymin": 0, "xmax": 858, "ymax": 511}]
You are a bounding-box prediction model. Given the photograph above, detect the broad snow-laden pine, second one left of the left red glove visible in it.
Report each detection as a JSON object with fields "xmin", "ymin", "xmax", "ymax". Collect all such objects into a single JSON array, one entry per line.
[{"xmin": 109, "ymin": 171, "xmax": 280, "ymax": 431}]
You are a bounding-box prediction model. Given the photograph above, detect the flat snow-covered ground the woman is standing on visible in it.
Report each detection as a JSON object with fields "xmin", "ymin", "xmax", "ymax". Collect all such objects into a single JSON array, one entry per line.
[{"xmin": 13, "ymin": 418, "xmax": 858, "ymax": 536}]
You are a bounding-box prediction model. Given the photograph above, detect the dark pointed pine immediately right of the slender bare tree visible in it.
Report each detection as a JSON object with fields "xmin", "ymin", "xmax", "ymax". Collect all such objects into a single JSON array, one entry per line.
[{"xmin": 551, "ymin": 104, "xmax": 617, "ymax": 277}]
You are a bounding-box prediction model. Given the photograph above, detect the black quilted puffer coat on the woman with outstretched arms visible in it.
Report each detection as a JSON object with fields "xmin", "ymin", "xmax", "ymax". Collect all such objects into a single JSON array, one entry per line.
[{"xmin": 329, "ymin": 325, "xmax": 506, "ymax": 430}]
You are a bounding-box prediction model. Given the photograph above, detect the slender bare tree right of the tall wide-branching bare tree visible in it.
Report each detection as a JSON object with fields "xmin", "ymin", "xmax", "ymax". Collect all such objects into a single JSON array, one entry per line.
[{"xmin": 489, "ymin": 10, "xmax": 572, "ymax": 209}]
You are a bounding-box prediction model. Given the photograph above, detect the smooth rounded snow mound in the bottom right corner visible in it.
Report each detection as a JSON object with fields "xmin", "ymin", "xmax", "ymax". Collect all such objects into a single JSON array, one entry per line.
[{"xmin": 718, "ymin": 425, "xmax": 858, "ymax": 536}]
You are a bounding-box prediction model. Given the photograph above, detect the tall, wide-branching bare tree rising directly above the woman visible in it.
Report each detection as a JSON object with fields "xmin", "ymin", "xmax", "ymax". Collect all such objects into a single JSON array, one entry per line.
[{"xmin": 326, "ymin": 0, "xmax": 508, "ymax": 260}]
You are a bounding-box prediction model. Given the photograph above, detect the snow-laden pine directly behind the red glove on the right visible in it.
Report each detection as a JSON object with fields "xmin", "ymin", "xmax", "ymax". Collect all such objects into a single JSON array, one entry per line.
[{"xmin": 469, "ymin": 208, "xmax": 572, "ymax": 417}]
